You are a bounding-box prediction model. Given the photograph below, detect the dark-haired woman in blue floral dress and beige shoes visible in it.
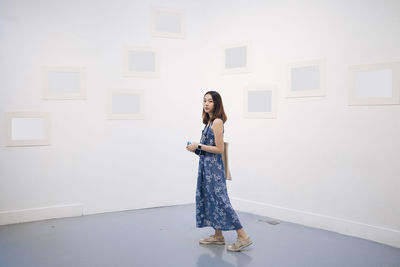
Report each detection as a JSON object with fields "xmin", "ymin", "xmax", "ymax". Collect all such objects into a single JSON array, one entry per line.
[{"xmin": 186, "ymin": 91, "xmax": 252, "ymax": 251}]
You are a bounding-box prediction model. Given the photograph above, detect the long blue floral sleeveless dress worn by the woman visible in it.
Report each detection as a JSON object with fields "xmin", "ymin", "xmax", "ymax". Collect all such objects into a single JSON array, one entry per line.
[{"xmin": 196, "ymin": 122, "xmax": 242, "ymax": 231}]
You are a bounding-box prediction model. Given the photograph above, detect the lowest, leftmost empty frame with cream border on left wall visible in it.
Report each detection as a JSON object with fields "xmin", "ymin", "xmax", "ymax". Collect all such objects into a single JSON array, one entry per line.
[{"xmin": 4, "ymin": 112, "xmax": 51, "ymax": 146}]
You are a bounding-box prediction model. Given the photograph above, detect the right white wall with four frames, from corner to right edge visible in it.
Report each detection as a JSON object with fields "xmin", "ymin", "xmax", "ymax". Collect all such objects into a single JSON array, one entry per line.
[{"xmin": 199, "ymin": 1, "xmax": 400, "ymax": 247}]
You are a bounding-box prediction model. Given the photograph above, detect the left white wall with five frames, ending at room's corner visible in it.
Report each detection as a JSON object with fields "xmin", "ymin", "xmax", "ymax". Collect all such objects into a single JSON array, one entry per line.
[{"xmin": 0, "ymin": 0, "xmax": 203, "ymax": 218}]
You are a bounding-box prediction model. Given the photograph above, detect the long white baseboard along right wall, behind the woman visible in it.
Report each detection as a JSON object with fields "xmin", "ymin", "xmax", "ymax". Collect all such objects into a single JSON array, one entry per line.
[{"xmin": 230, "ymin": 197, "xmax": 400, "ymax": 248}]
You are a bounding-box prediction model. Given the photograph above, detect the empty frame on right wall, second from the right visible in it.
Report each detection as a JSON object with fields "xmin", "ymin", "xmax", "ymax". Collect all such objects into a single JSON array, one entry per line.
[{"xmin": 286, "ymin": 60, "xmax": 326, "ymax": 97}]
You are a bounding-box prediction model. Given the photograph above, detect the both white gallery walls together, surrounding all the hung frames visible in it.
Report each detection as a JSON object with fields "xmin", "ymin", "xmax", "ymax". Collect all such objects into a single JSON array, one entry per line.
[{"xmin": 0, "ymin": 0, "xmax": 400, "ymax": 247}]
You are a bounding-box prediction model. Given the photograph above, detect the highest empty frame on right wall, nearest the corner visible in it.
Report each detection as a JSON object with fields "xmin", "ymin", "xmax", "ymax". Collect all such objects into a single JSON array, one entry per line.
[{"xmin": 222, "ymin": 42, "xmax": 251, "ymax": 74}]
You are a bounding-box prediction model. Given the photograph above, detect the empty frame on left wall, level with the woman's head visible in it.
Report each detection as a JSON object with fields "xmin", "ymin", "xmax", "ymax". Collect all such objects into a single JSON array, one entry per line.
[{"xmin": 107, "ymin": 89, "xmax": 144, "ymax": 120}]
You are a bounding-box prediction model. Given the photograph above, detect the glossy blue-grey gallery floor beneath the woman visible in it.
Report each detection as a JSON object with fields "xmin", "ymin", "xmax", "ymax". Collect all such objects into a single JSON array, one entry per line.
[{"xmin": 0, "ymin": 204, "xmax": 400, "ymax": 267}]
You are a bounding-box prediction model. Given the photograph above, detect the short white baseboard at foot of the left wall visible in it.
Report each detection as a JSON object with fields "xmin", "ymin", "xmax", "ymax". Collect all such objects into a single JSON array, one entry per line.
[{"xmin": 0, "ymin": 203, "xmax": 83, "ymax": 225}]
